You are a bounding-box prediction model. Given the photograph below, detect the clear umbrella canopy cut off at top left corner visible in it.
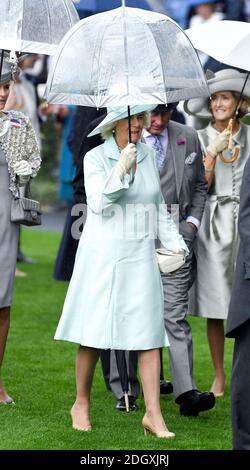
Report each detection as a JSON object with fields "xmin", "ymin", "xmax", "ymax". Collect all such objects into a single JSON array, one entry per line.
[{"xmin": 0, "ymin": 0, "xmax": 79, "ymax": 55}]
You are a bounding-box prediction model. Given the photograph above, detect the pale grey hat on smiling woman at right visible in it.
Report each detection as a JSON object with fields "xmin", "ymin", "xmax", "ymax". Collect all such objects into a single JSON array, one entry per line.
[{"xmin": 184, "ymin": 69, "xmax": 250, "ymax": 118}]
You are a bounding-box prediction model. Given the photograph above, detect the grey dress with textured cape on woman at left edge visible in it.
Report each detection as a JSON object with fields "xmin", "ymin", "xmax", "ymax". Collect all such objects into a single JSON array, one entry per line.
[{"xmin": 0, "ymin": 111, "xmax": 41, "ymax": 308}]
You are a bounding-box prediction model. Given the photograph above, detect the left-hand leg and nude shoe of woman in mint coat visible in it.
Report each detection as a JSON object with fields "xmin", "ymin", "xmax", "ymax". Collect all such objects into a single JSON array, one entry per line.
[{"xmin": 71, "ymin": 346, "xmax": 100, "ymax": 431}]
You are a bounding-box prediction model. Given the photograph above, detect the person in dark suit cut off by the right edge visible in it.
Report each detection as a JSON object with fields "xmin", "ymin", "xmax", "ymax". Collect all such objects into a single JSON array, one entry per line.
[{"xmin": 226, "ymin": 154, "xmax": 250, "ymax": 450}]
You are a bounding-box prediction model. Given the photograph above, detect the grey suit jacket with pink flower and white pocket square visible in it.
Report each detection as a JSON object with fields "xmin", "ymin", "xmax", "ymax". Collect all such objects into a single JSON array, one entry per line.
[{"xmin": 160, "ymin": 121, "xmax": 207, "ymax": 242}]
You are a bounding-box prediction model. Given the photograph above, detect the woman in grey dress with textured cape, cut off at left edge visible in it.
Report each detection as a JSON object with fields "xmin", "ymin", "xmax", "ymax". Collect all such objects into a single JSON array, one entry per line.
[{"xmin": 0, "ymin": 55, "xmax": 41, "ymax": 404}]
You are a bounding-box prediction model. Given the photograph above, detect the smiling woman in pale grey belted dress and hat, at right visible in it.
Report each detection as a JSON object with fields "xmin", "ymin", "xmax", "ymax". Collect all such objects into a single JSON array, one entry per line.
[{"xmin": 186, "ymin": 69, "xmax": 250, "ymax": 396}]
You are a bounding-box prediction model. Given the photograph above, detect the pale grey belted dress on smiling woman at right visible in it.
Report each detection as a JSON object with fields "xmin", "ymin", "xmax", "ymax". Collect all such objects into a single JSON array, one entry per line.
[{"xmin": 189, "ymin": 124, "xmax": 250, "ymax": 319}]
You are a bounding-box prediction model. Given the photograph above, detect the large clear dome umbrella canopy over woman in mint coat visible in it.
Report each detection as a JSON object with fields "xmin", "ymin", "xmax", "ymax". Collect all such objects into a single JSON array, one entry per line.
[{"xmin": 46, "ymin": 6, "xmax": 209, "ymax": 108}]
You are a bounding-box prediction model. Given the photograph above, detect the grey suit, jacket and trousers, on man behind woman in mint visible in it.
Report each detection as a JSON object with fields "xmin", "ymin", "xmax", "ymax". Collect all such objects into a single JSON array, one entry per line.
[{"xmin": 160, "ymin": 121, "xmax": 207, "ymax": 398}]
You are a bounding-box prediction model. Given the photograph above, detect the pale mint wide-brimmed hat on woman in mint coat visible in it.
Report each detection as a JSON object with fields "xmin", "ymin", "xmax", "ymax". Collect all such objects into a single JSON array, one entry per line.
[{"xmin": 88, "ymin": 104, "xmax": 156, "ymax": 137}]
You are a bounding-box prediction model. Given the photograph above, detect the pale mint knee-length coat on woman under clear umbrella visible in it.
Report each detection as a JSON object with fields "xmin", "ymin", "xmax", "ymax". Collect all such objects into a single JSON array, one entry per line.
[{"xmin": 55, "ymin": 137, "xmax": 187, "ymax": 350}]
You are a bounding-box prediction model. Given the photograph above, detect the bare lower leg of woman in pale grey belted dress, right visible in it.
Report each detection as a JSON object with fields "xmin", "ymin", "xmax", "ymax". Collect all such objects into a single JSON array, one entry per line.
[{"xmin": 207, "ymin": 318, "xmax": 225, "ymax": 396}]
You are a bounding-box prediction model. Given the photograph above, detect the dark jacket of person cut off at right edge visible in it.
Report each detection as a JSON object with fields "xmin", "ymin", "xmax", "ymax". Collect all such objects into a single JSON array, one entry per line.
[{"xmin": 226, "ymin": 158, "xmax": 250, "ymax": 338}]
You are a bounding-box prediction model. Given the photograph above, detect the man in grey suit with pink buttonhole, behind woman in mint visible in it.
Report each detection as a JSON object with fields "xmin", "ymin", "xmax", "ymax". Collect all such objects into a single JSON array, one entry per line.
[{"xmin": 143, "ymin": 104, "xmax": 215, "ymax": 416}]
